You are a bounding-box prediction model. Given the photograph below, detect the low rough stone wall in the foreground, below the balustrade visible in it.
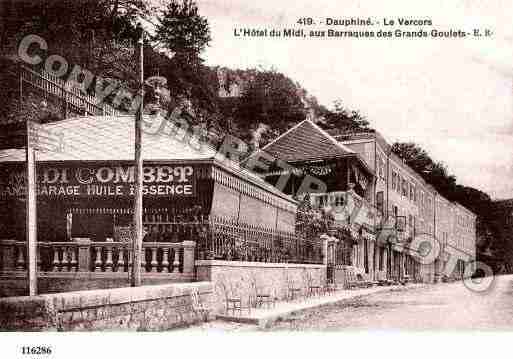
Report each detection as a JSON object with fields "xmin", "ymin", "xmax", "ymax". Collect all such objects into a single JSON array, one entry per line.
[{"xmin": 0, "ymin": 282, "xmax": 212, "ymax": 331}]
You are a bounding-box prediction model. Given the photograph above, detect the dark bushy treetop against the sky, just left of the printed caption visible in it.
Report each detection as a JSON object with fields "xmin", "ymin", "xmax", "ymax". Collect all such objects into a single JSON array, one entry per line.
[{"xmin": 154, "ymin": 0, "xmax": 211, "ymax": 60}]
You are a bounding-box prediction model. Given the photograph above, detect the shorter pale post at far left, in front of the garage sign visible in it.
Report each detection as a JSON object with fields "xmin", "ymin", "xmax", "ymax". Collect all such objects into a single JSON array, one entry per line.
[{"xmin": 25, "ymin": 120, "xmax": 37, "ymax": 296}]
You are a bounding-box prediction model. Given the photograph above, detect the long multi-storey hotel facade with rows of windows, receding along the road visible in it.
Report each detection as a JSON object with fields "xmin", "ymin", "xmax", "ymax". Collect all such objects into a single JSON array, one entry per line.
[{"xmin": 333, "ymin": 131, "xmax": 476, "ymax": 282}]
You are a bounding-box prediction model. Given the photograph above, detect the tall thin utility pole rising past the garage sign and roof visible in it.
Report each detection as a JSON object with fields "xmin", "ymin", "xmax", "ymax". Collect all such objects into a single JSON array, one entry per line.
[{"xmin": 130, "ymin": 24, "xmax": 145, "ymax": 287}]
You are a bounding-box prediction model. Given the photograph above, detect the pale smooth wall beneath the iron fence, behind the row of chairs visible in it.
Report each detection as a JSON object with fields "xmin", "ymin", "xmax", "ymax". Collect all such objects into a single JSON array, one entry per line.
[{"xmin": 196, "ymin": 260, "xmax": 326, "ymax": 314}]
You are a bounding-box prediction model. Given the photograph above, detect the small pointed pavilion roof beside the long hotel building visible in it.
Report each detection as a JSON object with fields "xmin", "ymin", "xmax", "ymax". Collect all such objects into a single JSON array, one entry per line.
[{"xmin": 262, "ymin": 119, "xmax": 356, "ymax": 162}]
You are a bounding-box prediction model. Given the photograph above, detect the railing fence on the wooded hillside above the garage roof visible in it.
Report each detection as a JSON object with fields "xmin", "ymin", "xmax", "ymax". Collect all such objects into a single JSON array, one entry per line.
[{"xmin": 19, "ymin": 66, "xmax": 123, "ymax": 116}]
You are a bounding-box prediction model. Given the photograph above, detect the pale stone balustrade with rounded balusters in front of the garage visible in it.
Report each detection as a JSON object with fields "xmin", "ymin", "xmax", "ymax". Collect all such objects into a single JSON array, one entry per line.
[{"xmin": 0, "ymin": 239, "xmax": 196, "ymax": 274}]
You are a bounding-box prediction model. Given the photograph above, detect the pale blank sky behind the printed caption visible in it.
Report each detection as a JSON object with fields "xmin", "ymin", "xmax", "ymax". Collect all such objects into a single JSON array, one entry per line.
[{"xmin": 193, "ymin": 0, "xmax": 513, "ymax": 198}]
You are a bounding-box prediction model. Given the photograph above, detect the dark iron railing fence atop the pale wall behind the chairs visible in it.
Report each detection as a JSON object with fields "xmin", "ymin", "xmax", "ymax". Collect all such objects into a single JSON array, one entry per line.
[{"xmin": 140, "ymin": 214, "xmax": 323, "ymax": 264}]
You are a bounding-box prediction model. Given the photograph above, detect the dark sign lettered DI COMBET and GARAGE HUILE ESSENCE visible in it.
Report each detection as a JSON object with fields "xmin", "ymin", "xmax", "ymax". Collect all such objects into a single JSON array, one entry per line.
[{"xmin": 0, "ymin": 165, "xmax": 196, "ymax": 197}]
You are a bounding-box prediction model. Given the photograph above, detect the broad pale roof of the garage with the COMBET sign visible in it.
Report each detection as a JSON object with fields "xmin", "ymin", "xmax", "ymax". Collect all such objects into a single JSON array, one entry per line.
[{"xmin": 0, "ymin": 116, "xmax": 296, "ymax": 203}]
